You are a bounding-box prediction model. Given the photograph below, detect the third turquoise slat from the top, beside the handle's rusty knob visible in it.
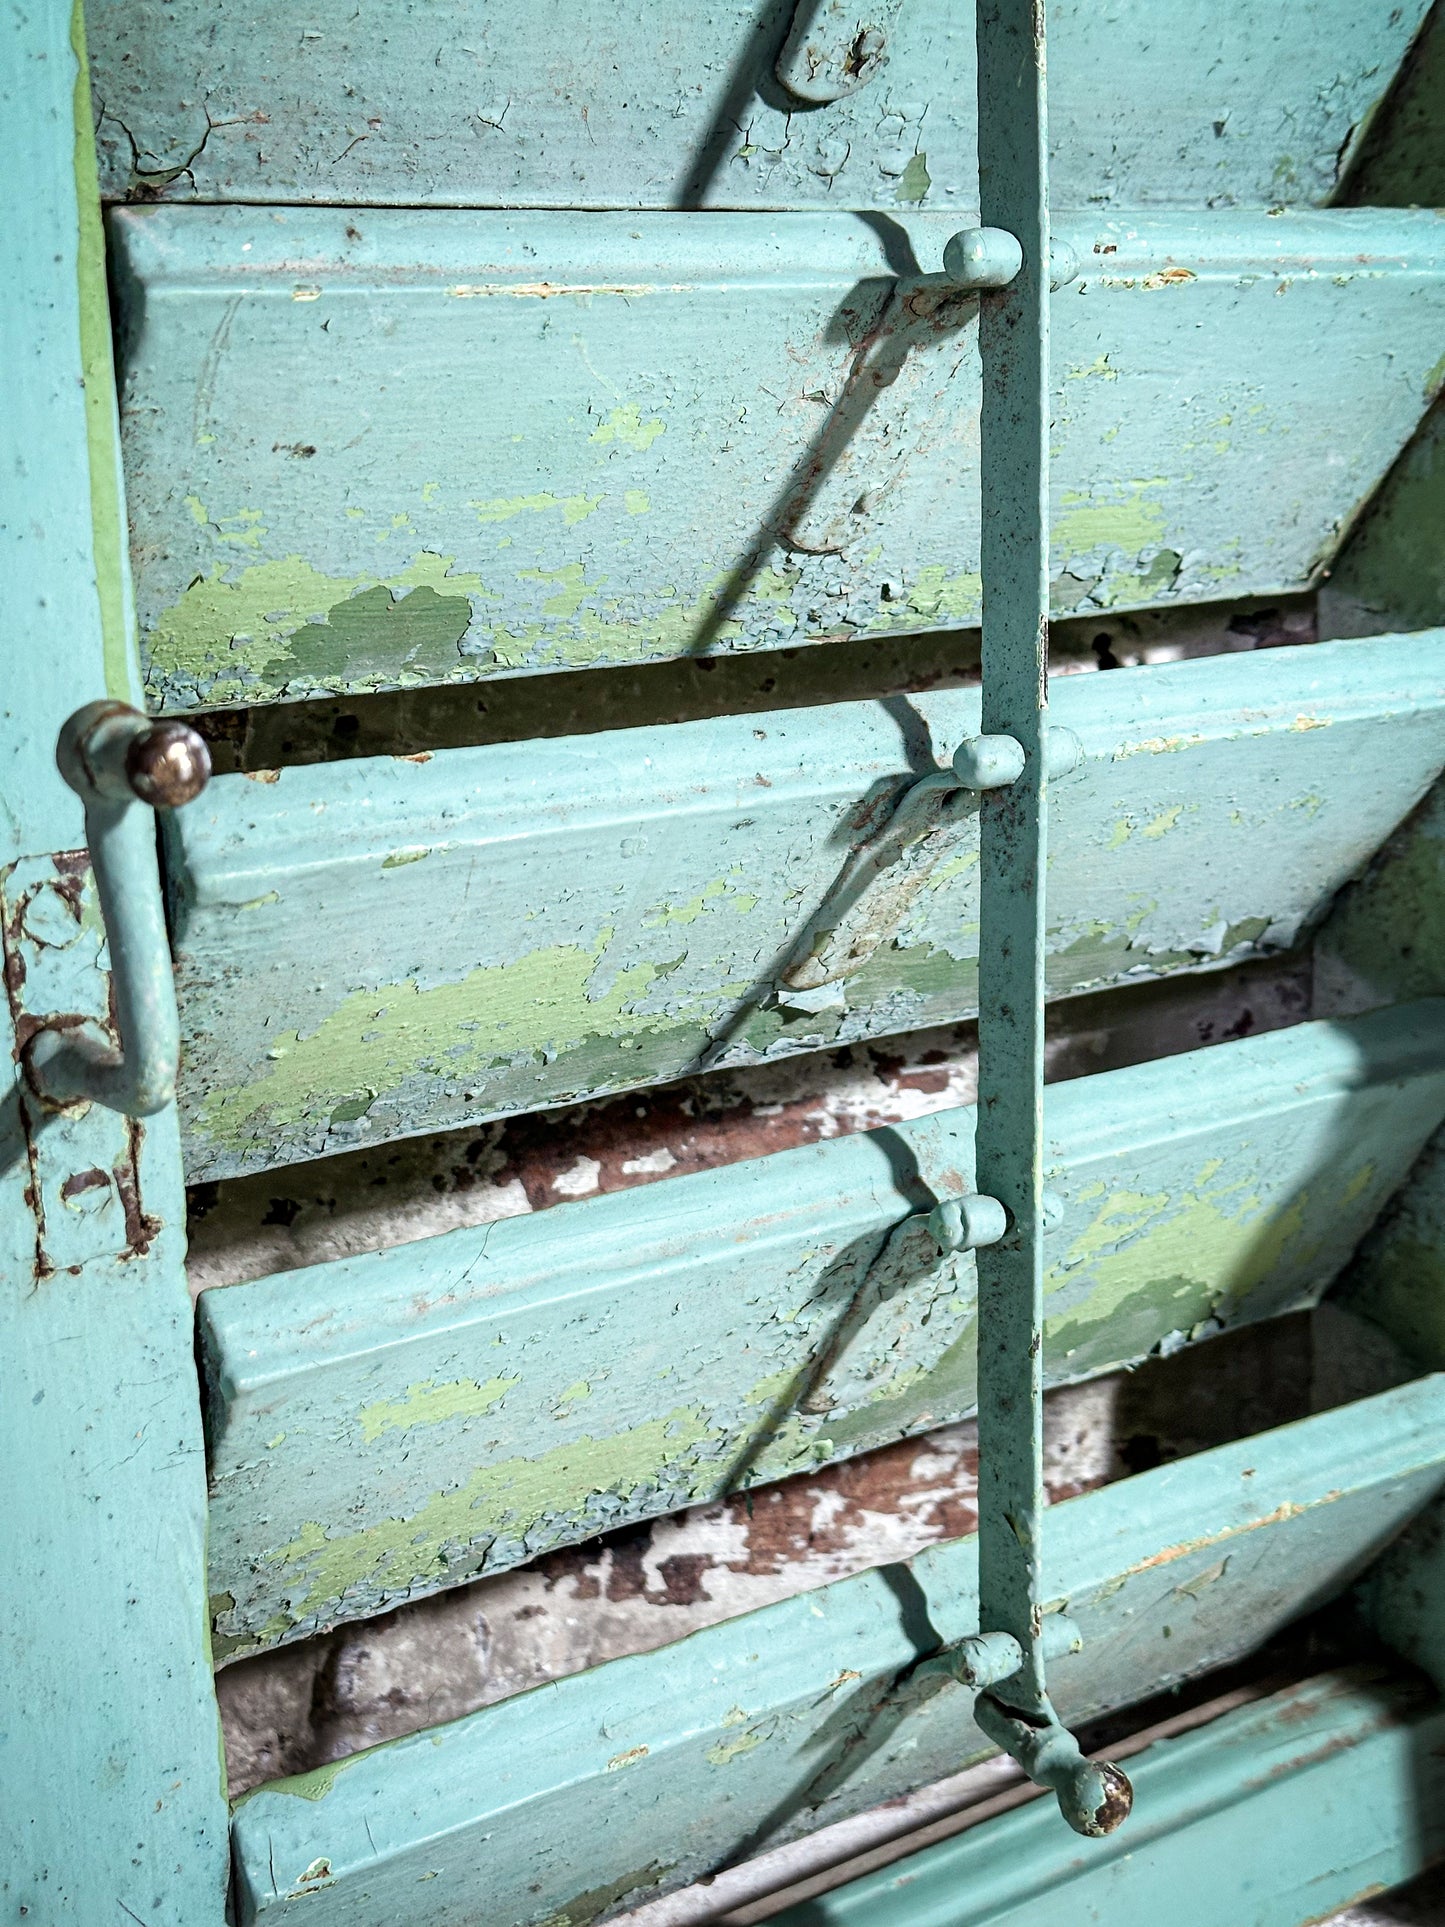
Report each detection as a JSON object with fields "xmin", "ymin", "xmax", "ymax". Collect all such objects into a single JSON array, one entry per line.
[{"xmin": 171, "ymin": 632, "xmax": 1445, "ymax": 1177}]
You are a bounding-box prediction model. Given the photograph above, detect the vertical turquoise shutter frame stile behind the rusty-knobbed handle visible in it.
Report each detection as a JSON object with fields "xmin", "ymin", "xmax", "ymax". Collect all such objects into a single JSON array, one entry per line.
[{"xmin": 0, "ymin": 4, "xmax": 227, "ymax": 1927}]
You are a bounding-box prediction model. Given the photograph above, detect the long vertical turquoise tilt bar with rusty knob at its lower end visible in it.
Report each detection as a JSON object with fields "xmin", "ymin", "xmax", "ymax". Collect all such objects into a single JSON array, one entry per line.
[{"xmin": 965, "ymin": 0, "xmax": 1131, "ymax": 1835}]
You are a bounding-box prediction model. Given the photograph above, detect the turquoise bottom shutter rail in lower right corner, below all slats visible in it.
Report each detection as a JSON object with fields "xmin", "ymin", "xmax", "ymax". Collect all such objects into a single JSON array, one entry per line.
[{"xmin": 775, "ymin": 1667, "xmax": 1445, "ymax": 1927}]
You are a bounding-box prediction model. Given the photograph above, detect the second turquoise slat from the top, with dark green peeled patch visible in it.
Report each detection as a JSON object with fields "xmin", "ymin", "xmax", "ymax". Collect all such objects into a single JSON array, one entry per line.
[{"xmin": 112, "ymin": 208, "xmax": 1445, "ymax": 709}]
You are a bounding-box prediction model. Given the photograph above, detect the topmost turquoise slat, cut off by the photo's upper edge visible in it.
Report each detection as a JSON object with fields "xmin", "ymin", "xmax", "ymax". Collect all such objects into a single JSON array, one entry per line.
[{"xmin": 87, "ymin": 0, "xmax": 1426, "ymax": 210}]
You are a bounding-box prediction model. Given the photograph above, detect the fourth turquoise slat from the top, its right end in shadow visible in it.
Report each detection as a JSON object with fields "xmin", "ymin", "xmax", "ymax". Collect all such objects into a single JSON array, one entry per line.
[{"xmin": 200, "ymin": 1000, "xmax": 1445, "ymax": 1655}]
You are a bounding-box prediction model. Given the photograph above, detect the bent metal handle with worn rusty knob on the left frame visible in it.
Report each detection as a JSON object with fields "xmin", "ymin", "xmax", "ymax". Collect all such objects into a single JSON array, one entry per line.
[{"xmin": 21, "ymin": 701, "xmax": 210, "ymax": 1118}]
